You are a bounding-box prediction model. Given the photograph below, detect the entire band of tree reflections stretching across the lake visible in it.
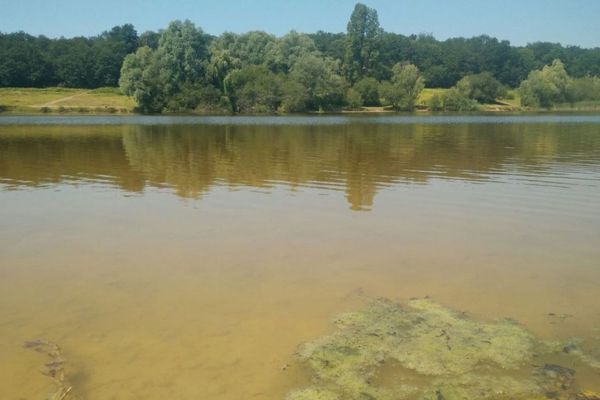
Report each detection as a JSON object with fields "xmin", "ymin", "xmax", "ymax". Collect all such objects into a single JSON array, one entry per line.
[{"xmin": 0, "ymin": 124, "xmax": 600, "ymax": 210}]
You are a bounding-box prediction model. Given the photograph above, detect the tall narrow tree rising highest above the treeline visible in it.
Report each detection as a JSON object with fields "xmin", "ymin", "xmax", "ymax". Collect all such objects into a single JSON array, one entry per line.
[{"xmin": 345, "ymin": 3, "xmax": 383, "ymax": 83}]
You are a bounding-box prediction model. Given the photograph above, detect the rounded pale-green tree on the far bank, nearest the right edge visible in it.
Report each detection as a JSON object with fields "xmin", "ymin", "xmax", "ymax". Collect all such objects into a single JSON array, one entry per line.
[{"xmin": 519, "ymin": 59, "xmax": 571, "ymax": 108}]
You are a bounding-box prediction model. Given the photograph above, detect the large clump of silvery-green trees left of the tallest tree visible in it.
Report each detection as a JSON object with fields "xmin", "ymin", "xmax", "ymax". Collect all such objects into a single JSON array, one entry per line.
[{"xmin": 121, "ymin": 25, "xmax": 347, "ymax": 112}]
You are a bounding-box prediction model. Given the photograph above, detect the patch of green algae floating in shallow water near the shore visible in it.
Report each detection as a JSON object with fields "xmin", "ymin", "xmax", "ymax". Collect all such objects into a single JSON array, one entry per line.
[{"xmin": 286, "ymin": 299, "xmax": 592, "ymax": 400}]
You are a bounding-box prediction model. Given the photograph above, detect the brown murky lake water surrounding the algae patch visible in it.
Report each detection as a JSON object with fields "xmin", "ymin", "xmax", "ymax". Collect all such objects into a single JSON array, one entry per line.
[{"xmin": 0, "ymin": 116, "xmax": 600, "ymax": 400}]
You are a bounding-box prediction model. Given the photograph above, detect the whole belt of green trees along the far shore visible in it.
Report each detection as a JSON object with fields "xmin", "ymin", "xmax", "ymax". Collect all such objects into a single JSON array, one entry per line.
[{"xmin": 0, "ymin": 3, "xmax": 600, "ymax": 113}]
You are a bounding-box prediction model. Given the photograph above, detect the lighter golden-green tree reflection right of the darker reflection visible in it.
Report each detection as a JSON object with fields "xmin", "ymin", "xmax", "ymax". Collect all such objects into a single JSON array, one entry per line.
[{"xmin": 124, "ymin": 124, "xmax": 600, "ymax": 210}]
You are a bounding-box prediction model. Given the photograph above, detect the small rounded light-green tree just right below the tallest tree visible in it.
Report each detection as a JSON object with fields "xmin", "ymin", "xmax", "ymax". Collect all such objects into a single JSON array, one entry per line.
[{"xmin": 382, "ymin": 64, "xmax": 425, "ymax": 111}]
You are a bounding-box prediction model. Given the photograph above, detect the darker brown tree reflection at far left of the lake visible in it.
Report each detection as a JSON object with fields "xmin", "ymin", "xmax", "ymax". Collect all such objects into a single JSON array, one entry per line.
[{"xmin": 0, "ymin": 125, "xmax": 145, "ymax": 192}]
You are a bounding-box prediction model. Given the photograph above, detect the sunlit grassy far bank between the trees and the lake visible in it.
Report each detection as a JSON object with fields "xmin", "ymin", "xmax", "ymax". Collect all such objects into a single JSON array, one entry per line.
[{"xmin": 0, "ymin": 87, "xmax": 600, "ymax": 115}]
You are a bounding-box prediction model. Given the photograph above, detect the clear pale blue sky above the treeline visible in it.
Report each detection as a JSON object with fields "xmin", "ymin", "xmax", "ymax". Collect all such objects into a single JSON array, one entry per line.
[{"xmin": 0, "ymin": 0, "xmax": 600, "ymax": 47}]
